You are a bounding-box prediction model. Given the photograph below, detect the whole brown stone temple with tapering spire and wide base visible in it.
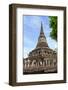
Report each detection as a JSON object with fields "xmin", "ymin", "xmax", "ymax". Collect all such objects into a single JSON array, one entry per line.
[{"xmin": 23, "ymin": 23, "xmax": 57, "ymax": 74}]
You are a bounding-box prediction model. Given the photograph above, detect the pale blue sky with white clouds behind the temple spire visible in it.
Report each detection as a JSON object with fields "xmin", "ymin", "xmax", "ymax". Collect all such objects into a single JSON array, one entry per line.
[{"xmin": 23, "ymin": 15, "xmax": 57, "ymax": 58}]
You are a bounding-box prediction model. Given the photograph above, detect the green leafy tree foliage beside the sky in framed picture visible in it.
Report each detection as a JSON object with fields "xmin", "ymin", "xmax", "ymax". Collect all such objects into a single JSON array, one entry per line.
[{"xmin": 49, "ymin": 16, "xmax": 57, "ymax": 41}]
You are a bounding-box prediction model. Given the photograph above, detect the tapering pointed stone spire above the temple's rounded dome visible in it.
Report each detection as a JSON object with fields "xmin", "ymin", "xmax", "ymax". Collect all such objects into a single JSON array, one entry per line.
[{"xmin": 36, "ymin": 23, "xmax": 48, "ymax": 48}]
